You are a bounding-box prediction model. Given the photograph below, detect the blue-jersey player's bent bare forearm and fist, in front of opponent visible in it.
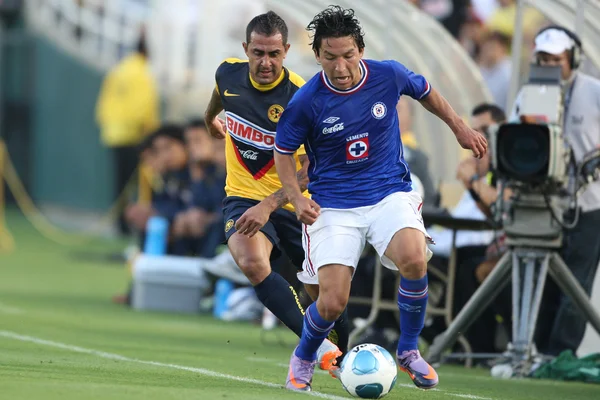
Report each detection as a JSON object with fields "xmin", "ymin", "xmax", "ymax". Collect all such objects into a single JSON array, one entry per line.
[{"xmin": 275, "ymin": 151, "xmax": 320, "ymax": 225}]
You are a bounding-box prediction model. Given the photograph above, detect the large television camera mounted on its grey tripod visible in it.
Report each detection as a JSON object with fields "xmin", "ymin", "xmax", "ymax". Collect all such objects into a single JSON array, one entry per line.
[{"xmin": 428, "ymin": 64, "xmax": 600, "ymax": 375}]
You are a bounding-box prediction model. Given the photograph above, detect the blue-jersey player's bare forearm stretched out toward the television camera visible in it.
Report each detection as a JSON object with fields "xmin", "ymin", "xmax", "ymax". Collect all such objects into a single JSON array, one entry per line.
[{"xmin": 419, "ymin": 88, "xmax": 487, "ymax": 158}]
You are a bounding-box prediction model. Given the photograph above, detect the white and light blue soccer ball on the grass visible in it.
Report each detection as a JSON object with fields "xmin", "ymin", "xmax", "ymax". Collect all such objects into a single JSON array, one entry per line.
[{"xmin": 338, "ymin": 343, "xmax": 398, "ymax": 399}]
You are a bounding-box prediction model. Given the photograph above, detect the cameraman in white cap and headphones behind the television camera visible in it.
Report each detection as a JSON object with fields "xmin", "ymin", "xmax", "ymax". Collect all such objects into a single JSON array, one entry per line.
[{"xmin": 510, "ymin": 26, "xmax": 600, "ymax": 355}]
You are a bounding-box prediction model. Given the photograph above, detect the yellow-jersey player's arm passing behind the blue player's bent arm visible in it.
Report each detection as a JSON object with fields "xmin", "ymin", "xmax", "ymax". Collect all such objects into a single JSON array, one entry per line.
[{"xmin": 235, "ymin": 154, "xmax": 310, "ymax": 237}]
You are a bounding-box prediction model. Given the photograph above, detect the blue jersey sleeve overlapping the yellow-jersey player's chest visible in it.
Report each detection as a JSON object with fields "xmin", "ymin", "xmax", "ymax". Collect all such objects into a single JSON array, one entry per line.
[{"xmin": 275, "ymin": 91, "xmax": 312, "ymax": 155}]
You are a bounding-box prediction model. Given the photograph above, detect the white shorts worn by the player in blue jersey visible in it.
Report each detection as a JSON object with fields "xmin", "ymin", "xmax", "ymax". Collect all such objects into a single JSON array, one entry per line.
[{"xmin": 298, "ymin": 191, "xmax": 433, "ymax": 284}]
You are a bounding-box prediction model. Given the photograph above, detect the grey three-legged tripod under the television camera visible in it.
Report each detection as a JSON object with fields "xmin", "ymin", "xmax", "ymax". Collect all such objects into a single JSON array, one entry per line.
[{"xmin": 426, "ymin": 197, "xmax": 600, "ymax": 375}]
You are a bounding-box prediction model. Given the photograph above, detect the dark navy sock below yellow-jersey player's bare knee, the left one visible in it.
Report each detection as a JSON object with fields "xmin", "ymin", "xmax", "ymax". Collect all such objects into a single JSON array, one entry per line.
[{"xmin": 254, "ymin": 271, "xmax": 304, "ymax": 337}]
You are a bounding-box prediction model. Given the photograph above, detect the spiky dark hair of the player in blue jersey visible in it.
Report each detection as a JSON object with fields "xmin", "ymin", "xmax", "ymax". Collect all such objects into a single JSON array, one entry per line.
[{"xmin": 306, "ymin": 6, "xmax": 365, "ymax": 54}]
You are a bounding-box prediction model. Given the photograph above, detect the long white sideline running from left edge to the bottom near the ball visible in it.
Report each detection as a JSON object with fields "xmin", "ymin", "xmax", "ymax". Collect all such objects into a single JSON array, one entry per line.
[{"xmin": 0, "ymin": 331, "xmax": 348, "ymax": 400}]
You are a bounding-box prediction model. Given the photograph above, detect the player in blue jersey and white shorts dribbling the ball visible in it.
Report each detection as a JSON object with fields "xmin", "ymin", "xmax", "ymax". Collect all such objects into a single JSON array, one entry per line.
[{"xmin": 275, "ymin": 6, "xmax": 487, "ymax": 391}]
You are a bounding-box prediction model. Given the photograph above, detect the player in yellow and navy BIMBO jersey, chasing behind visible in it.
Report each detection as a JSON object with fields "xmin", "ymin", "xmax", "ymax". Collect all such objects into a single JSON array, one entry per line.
[{"xmin": 205, "ymin": 11, "xmax": 348, "ymax": 369}]
